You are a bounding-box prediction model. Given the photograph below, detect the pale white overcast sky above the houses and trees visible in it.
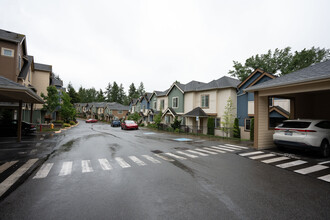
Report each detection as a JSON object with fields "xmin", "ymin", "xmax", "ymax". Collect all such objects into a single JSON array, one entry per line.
[{"xmin": 0, "ymin": 0, "xmax": 330, "ymax": 92}]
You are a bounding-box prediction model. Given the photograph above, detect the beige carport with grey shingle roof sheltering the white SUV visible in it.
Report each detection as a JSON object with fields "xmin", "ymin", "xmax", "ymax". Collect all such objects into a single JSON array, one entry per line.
[{"xmin": 245, "ymin": 60, "xmax": 330, "ymax": 149}]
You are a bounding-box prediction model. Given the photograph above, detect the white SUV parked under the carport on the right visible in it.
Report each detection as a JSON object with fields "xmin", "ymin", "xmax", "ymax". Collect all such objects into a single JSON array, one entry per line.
[{"xmin": 273, "ymin": 119, "xmax": 330, "ymax": 157}]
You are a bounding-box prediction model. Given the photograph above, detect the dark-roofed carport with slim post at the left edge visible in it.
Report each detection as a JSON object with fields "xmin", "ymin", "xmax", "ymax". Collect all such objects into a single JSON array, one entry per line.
[{"xmin": 0, "ymin": 76, "xmax": 44, "ymax": 142}]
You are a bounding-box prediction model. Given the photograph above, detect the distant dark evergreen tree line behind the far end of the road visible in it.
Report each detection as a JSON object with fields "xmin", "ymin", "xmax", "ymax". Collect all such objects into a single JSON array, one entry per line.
[{"xmin": 67, "ymin": 81, "xmax": 145, "ymax": 105}]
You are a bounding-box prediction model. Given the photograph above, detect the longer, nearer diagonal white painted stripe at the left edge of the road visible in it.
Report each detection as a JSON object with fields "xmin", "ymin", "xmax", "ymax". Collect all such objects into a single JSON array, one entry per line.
[{"xmin": 0, "ymin": 159, "xmax": 38, "ymax": 197}]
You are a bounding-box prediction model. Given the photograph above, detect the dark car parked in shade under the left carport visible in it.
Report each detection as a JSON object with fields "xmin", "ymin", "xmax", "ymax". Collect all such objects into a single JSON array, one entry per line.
[{"xmin": 0, "ymin": 120, "xmax": 37, "ymax": 136}]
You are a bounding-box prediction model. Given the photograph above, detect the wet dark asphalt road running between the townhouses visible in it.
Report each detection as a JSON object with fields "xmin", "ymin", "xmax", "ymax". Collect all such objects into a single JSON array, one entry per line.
[{"xmin": 0, "ymin": 119, "xmax": 330, "ymax": 219}]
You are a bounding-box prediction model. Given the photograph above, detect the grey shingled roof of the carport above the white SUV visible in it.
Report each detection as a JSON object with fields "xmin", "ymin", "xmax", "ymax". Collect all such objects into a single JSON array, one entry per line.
[{"xmin": 245, "ymin": 60, "xmax": 330, "ymax": 92}]
